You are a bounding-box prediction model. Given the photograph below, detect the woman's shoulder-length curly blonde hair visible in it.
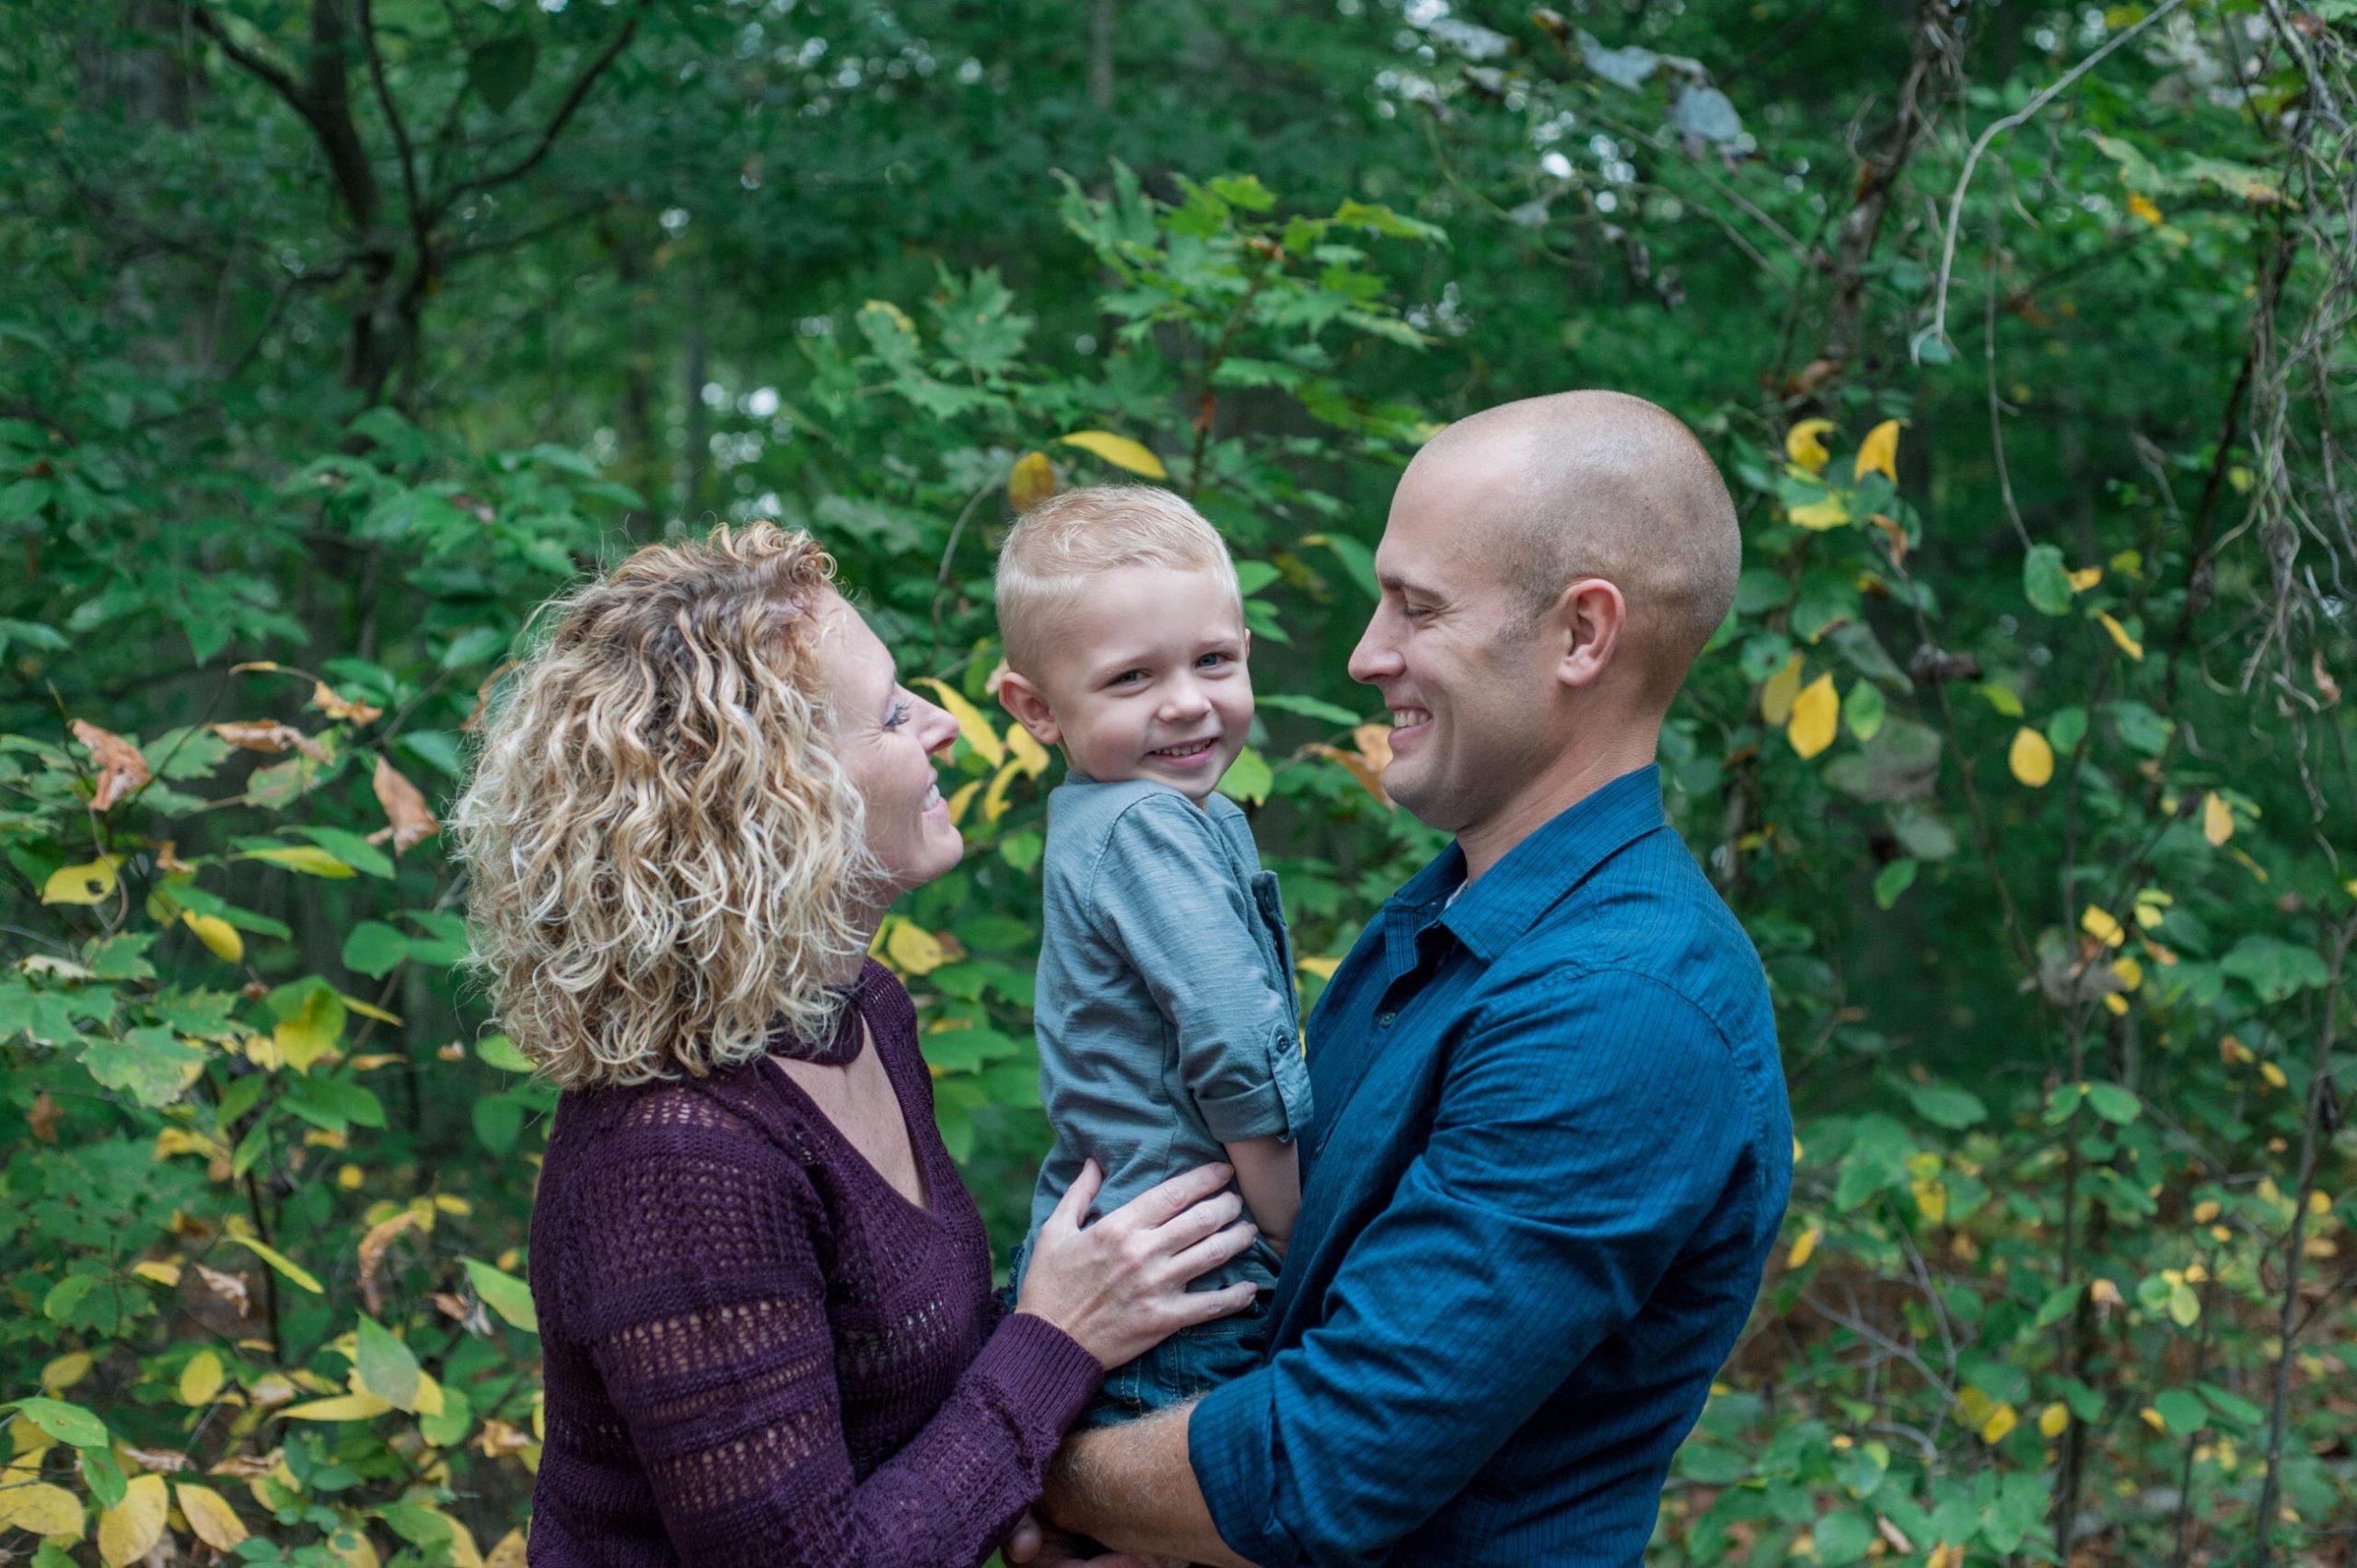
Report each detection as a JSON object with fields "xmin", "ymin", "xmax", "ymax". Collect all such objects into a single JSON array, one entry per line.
[{"xmin": 453, "ymin": 524, "xmax": 872, "ymax": 1089}]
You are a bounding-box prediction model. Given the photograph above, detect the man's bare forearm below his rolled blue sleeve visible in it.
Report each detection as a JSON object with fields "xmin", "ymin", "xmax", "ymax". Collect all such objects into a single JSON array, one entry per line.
[{"xmin": 1039, "ymin": 1403, "xmax": 1254, "ymax": 1568}]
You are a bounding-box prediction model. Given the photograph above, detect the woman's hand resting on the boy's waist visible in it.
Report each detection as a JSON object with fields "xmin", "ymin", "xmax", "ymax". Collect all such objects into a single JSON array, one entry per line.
[{"xmin": 1016, "ymin": 1160, "xmax": 1256, "ymax": 1367}]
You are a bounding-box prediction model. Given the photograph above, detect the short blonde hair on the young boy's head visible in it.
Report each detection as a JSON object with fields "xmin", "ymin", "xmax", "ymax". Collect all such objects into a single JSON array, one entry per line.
[{"xmin": 999, "ymin": 486, "xmax": 1245, "ymax": 679}]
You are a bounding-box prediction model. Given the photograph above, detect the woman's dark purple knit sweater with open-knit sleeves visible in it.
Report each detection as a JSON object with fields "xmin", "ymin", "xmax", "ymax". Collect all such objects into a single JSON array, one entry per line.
[{"xmin": 530, "ymin": 962, "xmax": 1101, "ymax": 1568}]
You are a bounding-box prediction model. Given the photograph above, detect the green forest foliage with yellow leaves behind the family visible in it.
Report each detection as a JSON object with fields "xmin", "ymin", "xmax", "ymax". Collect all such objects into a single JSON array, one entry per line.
[{"xmin": 0, "ymin": 0, "xmax": 2357, "ymax": 1568}]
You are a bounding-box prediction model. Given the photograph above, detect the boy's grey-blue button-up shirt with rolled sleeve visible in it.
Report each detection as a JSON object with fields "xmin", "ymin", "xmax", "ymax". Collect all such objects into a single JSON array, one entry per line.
[{"xmin": 1026, "ymin": 773, "xmax": 1310, "ymax": 1290}]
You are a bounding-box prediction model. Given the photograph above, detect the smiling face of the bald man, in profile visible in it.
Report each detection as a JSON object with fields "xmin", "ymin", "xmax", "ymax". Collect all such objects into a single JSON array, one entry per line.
[{"xmin": 1351, "ymin": 464, "xmax": 1562, "ymax": 835}]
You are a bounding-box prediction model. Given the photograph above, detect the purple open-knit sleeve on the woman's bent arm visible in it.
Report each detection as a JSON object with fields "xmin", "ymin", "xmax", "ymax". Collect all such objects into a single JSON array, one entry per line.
[{"xmin": 568, "ymin": 1098, "xmax": 1101, "ymax": 1568}]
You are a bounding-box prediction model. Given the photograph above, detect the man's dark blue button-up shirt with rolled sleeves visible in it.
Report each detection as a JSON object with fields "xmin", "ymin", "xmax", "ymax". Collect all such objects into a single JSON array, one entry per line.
[{"xmin": 1188, "ymin": 766, "xmax": 1792, "ymax": 1568}]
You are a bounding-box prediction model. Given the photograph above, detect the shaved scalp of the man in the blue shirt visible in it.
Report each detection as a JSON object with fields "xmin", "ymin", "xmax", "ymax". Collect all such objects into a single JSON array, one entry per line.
[{"xmin": 1402, "ymin": 391, "xmax": 1742, "ymax": 705}]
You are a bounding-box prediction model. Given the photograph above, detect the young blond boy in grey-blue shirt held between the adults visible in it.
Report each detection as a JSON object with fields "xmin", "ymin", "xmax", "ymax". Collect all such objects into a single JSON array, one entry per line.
[{"xmin": 997, "ymin": 486, "xmax": 1310, "ymax": 1429}]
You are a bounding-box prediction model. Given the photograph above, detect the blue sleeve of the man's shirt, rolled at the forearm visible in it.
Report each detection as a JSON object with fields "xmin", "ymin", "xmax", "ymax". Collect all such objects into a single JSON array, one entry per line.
[{"xmin": 1188, "ymin": 971, "xmax": 1751, "ymax": 1568}]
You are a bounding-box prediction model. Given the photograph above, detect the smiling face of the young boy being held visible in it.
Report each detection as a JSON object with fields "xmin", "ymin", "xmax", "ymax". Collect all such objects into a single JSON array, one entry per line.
[{"xmin": 999, "ymin": 566, "xmax": 1251, "ymax": 804}]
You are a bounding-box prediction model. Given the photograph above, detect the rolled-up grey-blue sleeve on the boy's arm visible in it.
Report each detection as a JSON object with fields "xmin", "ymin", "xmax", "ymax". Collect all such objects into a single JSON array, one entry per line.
[{"xmin": 1089, "ymin": 792, "xmax": 1308, "ymax": 1144}]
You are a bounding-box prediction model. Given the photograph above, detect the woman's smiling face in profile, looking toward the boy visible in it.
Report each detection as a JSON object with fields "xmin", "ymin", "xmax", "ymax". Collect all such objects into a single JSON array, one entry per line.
[{"xmin": 818, "ymin": 594, "xmax": 967, "ymax": 894}]
